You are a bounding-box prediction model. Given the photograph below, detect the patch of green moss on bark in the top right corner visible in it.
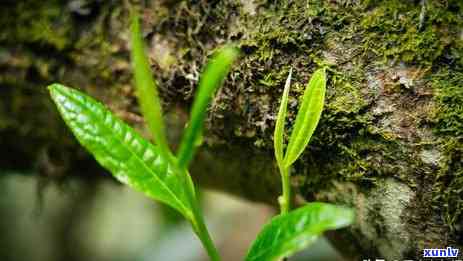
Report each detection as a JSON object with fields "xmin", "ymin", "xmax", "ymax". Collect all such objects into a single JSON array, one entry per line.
[{"xmin": 361, "ymin": 0, "xmax": 463, "ymax": 66}]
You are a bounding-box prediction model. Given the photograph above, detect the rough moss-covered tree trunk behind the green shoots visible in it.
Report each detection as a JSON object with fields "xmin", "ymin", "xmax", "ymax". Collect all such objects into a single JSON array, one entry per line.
[{"xmin": 0, "ymin": 0, "xmax": 463, "ymax": 260}]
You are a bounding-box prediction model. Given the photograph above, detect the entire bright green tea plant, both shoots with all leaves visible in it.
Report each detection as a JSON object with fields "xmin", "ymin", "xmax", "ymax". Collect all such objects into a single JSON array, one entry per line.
[{"xmin": 48, "ymin": 9, "xmax": 352, "ymax": 261}]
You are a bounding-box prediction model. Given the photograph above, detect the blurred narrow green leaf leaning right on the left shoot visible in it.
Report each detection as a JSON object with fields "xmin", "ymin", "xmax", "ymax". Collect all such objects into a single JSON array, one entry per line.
[{"xmin": 178, "ymin": 46, "xmax": 239, "ymax": 168}]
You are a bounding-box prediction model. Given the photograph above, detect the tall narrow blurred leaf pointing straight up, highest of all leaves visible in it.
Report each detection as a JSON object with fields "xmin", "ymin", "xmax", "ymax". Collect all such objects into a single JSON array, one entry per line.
[{"xmin": 130, "ymin": 11, "xmax": 172, "ymax": 162}]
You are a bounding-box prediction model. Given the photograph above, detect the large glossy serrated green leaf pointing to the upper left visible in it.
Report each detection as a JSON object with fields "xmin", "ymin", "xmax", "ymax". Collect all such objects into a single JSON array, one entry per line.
[{"xmin": 48, "ymin": 84, "xmax": 192, "ymax": 220}]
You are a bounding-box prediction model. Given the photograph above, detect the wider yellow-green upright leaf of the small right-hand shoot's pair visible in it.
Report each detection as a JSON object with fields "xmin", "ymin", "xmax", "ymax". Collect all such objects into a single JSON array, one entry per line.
[{"xmin": 284, "ymin": 69, "xmax": 326, "ymax": 167}]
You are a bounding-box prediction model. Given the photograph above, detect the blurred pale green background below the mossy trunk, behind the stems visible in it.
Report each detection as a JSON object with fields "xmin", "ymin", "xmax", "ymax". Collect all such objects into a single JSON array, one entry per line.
[{"xmin": 0, "ymin": 172, "xmax": 342, "ymax": 261}]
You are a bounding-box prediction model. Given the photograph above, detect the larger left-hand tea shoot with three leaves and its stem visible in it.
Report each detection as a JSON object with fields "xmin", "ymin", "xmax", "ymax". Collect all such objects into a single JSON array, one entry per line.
[{"xmin": 48, "ymin": 10, "xmax": 239, "ymax": 261}]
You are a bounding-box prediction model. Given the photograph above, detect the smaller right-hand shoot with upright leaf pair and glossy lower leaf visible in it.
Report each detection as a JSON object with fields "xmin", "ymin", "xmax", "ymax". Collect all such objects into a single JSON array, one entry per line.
[{"xmin": 246, "ymin": 69, "xmax": 354, "ymax": 261}]
